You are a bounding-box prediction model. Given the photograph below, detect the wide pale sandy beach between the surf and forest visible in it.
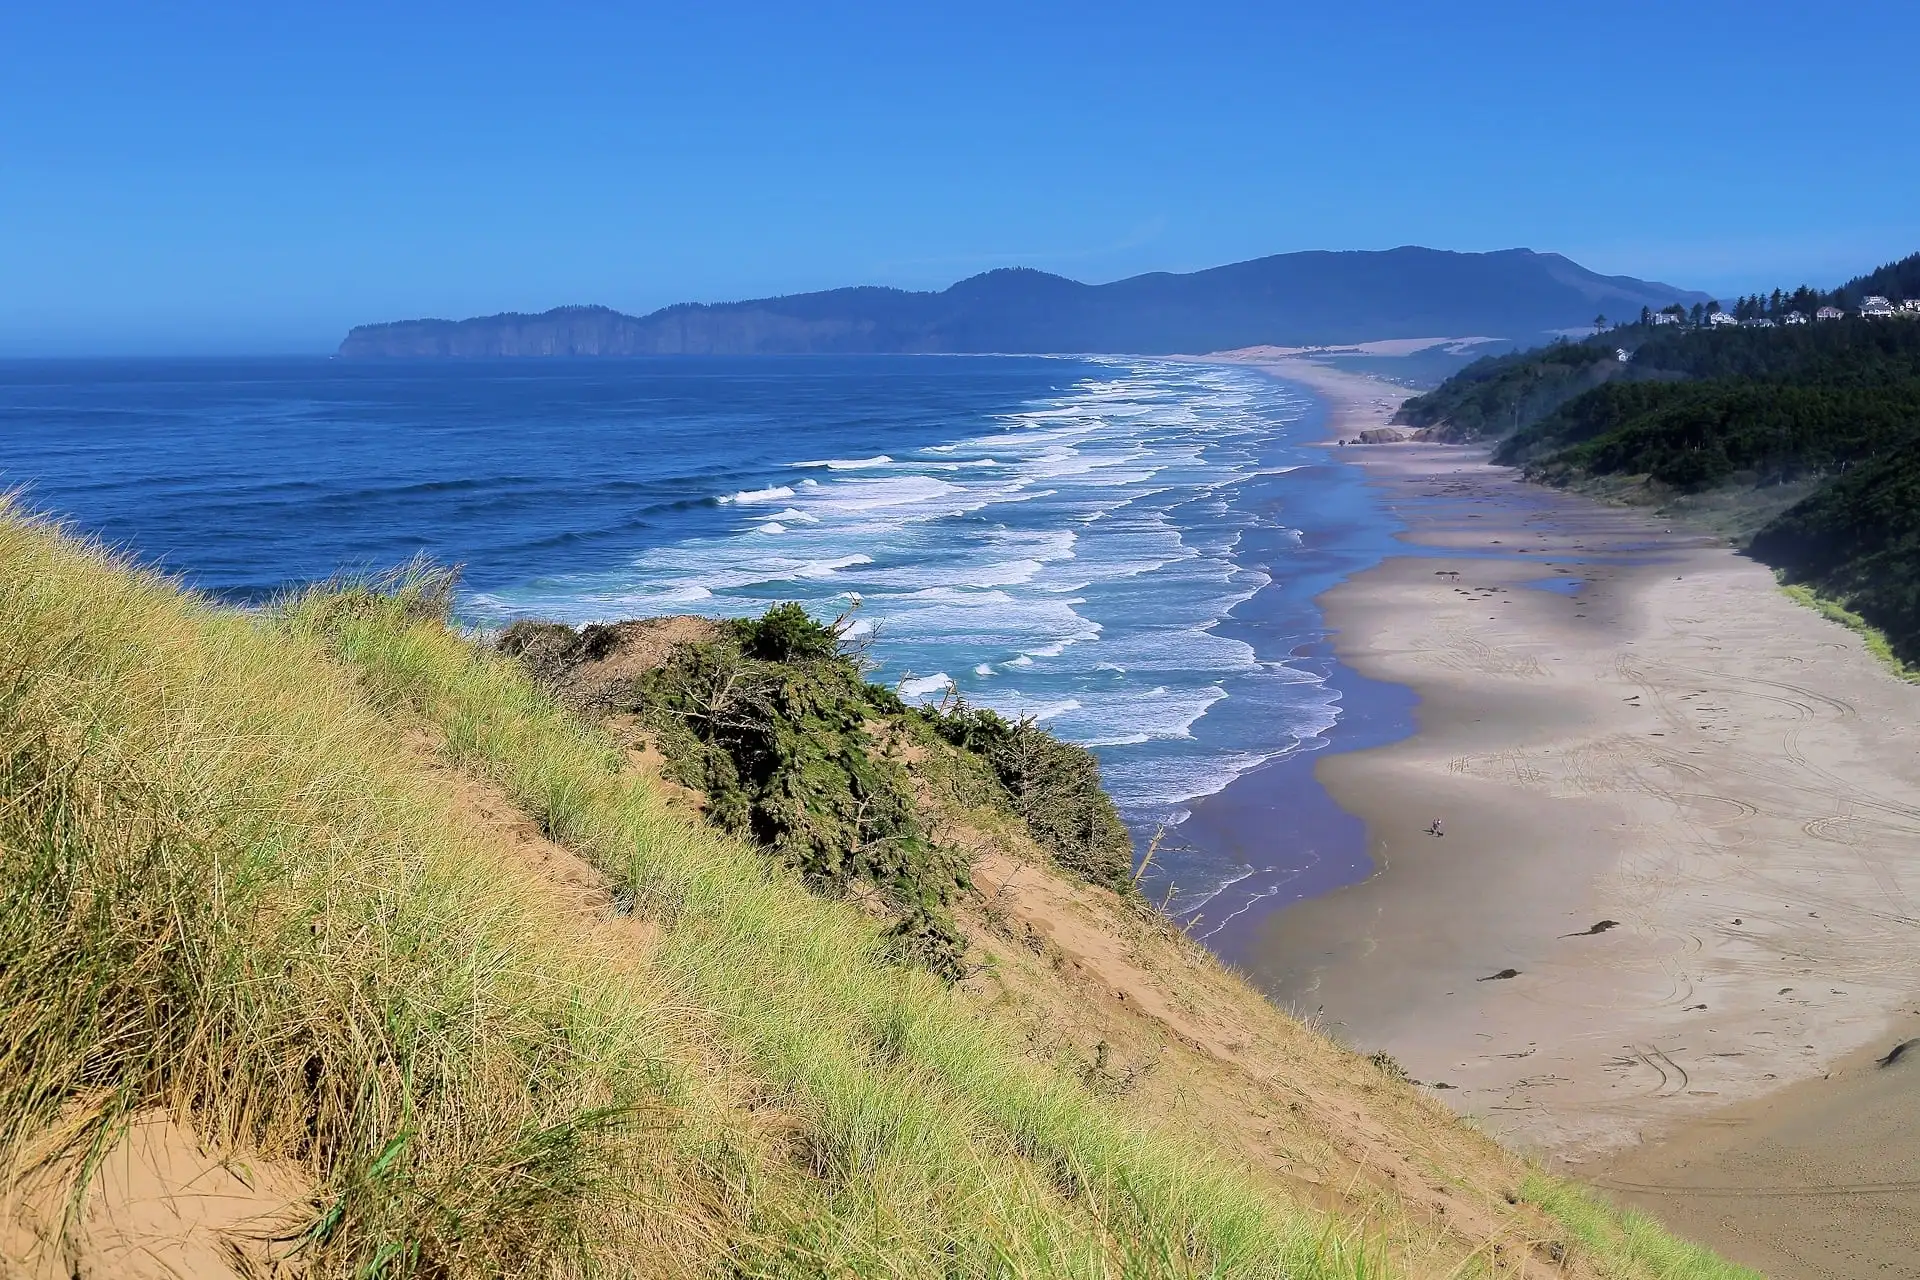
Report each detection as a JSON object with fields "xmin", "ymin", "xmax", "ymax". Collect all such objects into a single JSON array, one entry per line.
[{"xmin": 1250, "ymin": 361, "xmax": 1920, "ymax": 1276}]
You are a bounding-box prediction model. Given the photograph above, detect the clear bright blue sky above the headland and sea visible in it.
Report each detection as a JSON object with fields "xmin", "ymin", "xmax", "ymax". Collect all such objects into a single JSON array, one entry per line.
[{"xmin": 0, "ymin": 0, "xmax": 1920, "ymax": 355}]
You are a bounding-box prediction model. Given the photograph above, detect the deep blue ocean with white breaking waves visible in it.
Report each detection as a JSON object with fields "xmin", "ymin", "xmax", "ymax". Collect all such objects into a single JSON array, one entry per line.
[{"xmin": 0, "ymin": 357, "xmax": 1392, "ymax": 913}]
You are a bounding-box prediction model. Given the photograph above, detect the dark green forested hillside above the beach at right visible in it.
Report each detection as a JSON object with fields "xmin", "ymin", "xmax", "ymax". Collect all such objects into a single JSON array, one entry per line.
[{"xmin": 1396, "ymin": 253, "xmax": 1920, "ymax": 664}]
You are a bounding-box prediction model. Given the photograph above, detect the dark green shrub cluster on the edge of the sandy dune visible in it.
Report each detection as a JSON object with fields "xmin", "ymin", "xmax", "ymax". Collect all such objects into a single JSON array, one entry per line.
[{"xmin": 495, "ymin": 603, "xmax": 1135, "ymax": 979}]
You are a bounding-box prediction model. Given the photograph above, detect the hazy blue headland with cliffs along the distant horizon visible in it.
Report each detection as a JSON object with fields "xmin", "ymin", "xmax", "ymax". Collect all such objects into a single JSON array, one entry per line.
[{"xmin": 340, "ymin": 248, "xmax": 1707, "ymax": 357}]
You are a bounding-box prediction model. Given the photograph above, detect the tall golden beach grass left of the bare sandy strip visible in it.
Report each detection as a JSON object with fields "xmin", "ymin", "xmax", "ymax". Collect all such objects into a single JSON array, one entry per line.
[{"xmin": 0, "ymin": 512, "xmax": 710, "ymax": 1274}]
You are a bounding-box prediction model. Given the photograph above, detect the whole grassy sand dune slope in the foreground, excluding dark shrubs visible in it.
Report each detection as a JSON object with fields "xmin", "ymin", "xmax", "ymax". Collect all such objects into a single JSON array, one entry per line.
[{"xmin": 0, "ymin": 512, "xmax": 1743, "ymax": 1280}]
